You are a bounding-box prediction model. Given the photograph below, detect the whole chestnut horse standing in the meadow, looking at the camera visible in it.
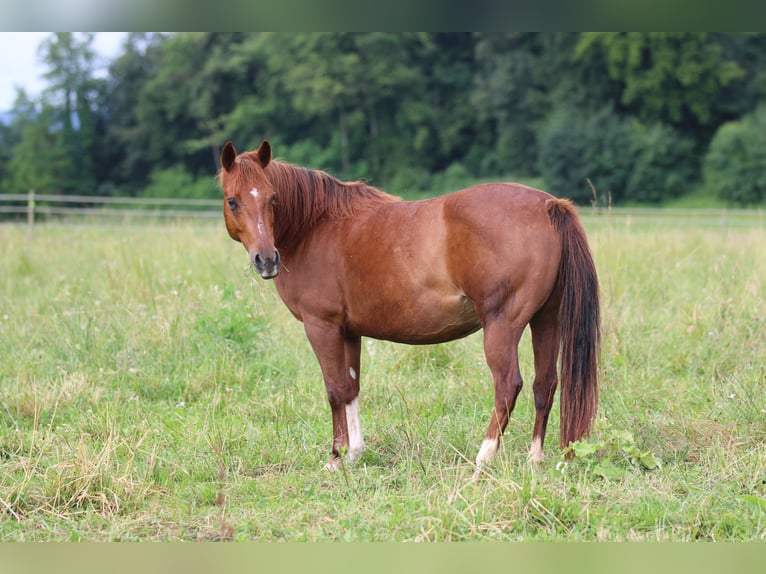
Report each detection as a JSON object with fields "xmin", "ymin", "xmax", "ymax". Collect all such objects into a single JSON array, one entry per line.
[{"xmin": 218, "ymin": 140, "xmax": 600, "ymax": 479}]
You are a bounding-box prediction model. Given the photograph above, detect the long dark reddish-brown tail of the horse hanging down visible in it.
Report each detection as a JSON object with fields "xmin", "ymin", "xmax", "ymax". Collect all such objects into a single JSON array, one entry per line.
[{"xmin": 546, "ymin": 199, "xmax": 601, "ymax": 454}]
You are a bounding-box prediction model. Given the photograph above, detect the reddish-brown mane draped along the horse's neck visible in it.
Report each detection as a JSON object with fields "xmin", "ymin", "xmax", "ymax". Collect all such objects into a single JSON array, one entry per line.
[{"xmin": 265, "ymin": 160, "xmax": 400, "ymax": 249}]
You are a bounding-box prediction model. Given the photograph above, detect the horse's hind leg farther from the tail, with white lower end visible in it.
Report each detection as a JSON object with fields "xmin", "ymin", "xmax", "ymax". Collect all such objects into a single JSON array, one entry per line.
[{"xmin": 473, "ymin": 317, "xmax": 524, "ymax": 479}]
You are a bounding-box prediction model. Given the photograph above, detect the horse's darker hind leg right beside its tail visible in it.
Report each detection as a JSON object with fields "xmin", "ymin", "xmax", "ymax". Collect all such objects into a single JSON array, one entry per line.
[{"xmin": 529, "ymin": 297, "xmax": 561, "ymax": 463}]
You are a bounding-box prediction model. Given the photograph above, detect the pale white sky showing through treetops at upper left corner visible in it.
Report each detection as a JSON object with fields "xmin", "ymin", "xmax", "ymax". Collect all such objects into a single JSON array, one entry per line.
[{"xmin": 0, "ymin": 32, "xmax": 127, "ymax": 112}]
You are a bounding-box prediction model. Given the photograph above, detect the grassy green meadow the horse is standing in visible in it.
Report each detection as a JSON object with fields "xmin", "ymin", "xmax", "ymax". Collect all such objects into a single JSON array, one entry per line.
[{"xmin": 0, "ymin": 210, "xmax": 766, "ymax": 541}]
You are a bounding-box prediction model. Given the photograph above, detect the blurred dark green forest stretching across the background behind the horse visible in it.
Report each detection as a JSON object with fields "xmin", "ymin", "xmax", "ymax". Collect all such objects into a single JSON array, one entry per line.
[{"xmin": 0, "ymin": 32, "xmax": 766, "ymax": 206}]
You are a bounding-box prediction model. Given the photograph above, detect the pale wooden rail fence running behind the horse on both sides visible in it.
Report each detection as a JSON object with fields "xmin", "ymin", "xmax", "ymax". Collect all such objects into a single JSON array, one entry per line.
[{"xmin": 0, "ymin": 192, "xmax": 766, "ymax": 228}]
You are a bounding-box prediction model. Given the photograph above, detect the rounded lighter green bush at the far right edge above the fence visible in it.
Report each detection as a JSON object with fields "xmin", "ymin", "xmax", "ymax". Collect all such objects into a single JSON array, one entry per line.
[{"xmin": 703, "ymin": 106, "xmax": 766, "ymax": 205}]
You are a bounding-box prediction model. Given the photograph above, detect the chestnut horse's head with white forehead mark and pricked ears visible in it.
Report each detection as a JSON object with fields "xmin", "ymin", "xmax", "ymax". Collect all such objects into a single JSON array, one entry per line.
[{"xmin": 219, "ymin": 141, "xmax": 279, "ymax": 279}]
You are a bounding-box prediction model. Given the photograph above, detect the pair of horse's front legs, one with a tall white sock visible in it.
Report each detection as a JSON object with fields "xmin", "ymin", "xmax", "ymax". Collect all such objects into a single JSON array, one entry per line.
[{"xmin": 305, "ymin": 322, "xmax": 364, "ymax": 470}]
